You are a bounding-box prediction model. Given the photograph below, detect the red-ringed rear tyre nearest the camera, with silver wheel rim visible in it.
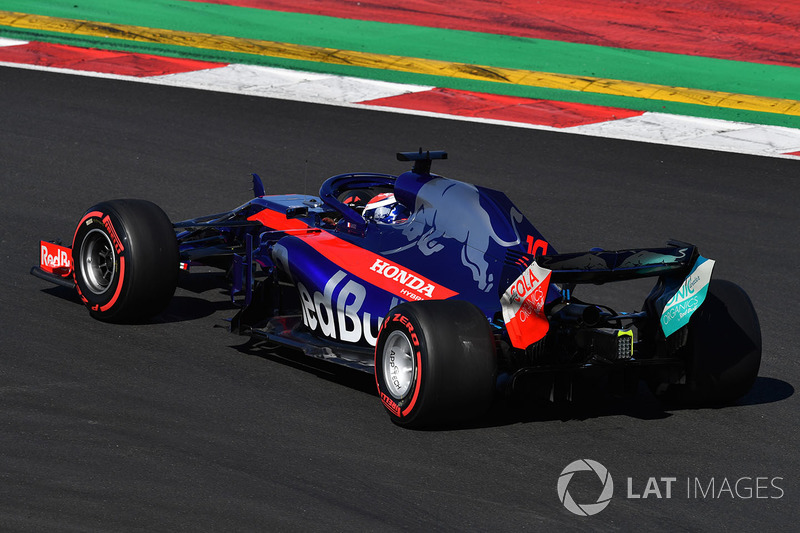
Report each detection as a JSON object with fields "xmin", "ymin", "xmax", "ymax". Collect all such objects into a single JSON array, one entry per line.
[{"xmin": 375, "ymin": 300, "xmax": 497, "ymax": 427}]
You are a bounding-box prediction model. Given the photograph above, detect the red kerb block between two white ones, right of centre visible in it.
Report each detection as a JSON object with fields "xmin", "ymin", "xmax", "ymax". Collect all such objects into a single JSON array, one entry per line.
[{"xmin": 359, "ymin": 89, "xmax": 643, "ymax": 128}]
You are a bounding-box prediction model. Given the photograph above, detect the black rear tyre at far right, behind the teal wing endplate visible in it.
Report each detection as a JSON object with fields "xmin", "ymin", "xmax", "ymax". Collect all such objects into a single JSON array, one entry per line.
[{"xmin": 660, "ymin": 280, "xmax": 761, "ymax": 407}]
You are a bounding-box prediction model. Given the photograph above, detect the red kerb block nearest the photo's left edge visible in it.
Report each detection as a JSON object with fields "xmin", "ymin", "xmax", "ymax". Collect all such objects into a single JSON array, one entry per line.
[{"xmin": 0, "ymin": 42, "xmax": 227, "ymax": 78}]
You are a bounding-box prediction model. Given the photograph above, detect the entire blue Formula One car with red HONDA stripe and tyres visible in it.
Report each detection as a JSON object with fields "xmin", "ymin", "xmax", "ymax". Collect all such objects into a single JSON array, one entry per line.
[{"xmin": 32, "ymin": 150, "xmax": 761, "ymax": 426}]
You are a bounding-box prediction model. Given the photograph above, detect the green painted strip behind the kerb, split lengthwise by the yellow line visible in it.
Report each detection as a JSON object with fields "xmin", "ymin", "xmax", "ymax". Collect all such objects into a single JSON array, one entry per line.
[{"xmin": 0, "ymin": 0, "xmax": 800, "ymax": 127}]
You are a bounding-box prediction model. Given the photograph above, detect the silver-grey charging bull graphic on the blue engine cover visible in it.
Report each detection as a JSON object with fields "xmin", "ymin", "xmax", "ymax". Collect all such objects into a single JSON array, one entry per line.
[{"xmin": 384, "ymin": 178, "xmax": 523, "ymax": 292}]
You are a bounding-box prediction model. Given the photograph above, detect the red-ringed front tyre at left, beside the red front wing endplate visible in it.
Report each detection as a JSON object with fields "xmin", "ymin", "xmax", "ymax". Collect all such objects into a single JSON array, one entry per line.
[{"xmin": 72, "ymin": 200, "xmax": 179, "ymax": 322}]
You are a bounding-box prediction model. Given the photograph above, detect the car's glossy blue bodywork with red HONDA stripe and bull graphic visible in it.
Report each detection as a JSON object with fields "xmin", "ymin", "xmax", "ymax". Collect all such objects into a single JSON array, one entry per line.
[{"xmin": 176, "ymin": 155, "xmax": 695, "ymax": 362}]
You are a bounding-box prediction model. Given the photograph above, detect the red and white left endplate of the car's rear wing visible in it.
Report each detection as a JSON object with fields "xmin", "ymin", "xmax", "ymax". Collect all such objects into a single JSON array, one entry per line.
[{"xmin": 500, "ymin": 261, "xmax": 551, "ymax": 349}]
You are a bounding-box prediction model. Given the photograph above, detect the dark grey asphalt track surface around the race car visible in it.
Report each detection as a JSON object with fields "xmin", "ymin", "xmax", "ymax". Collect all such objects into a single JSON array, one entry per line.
[{"xmin": 0, "ymin": 68, "xmax": 800, "ymax": 531}]
